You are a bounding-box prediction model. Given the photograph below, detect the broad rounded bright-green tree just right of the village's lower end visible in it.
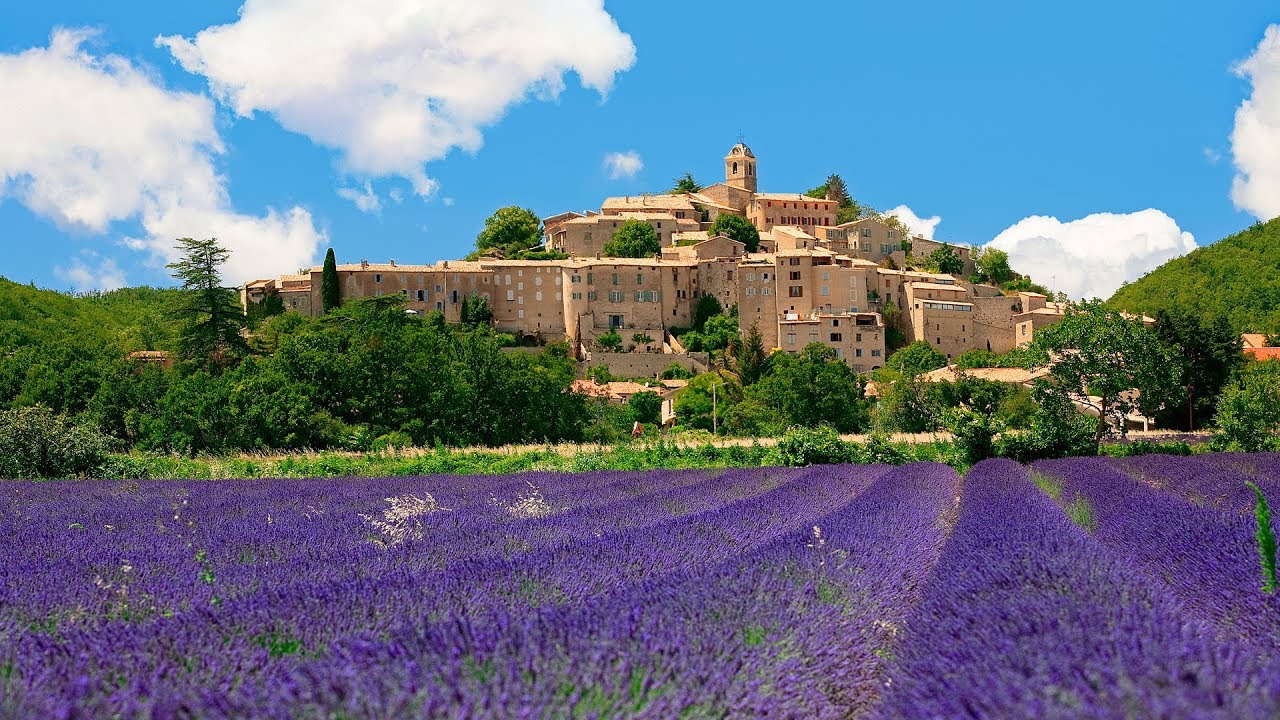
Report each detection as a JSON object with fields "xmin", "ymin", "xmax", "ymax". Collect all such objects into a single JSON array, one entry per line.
[{"xmin": 1025, "ymin": 301, "xmax": 1180, "ymax": 446}]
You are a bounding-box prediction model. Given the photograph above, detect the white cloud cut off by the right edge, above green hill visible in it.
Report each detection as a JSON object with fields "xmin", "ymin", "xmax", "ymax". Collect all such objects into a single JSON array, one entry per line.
[{"xmin": 1231, "ymin": 24, "xmax": 1280, "ymax": 220}]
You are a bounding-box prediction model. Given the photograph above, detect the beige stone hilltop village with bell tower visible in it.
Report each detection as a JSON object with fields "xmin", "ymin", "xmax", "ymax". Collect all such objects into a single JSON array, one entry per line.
[{"xmin": 241, "ymin": 142, "xmax": 1065, "ymax": 373}]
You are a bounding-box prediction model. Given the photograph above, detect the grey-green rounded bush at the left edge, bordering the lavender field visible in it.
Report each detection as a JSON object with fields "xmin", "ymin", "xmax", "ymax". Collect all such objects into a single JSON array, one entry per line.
[{"xmin": 0, "ymin": 407, "xmax": 110, "ymax": 479}]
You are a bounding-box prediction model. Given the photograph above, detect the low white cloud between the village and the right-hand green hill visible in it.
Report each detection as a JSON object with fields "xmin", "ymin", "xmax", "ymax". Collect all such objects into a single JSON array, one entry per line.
[{"xmin": 988, "ymin": 209, "xmax": 1196, "ymax": 299}]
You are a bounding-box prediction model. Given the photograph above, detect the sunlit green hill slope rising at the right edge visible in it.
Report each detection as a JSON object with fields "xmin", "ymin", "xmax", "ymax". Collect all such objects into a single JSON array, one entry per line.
[{"xmin": 1107, "ymin": 218, "xmax": 1280, "ymax": 332}]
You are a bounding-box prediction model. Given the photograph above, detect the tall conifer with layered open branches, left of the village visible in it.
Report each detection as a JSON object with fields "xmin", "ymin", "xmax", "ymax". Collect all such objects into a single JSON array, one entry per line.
[{"xmin": 168, "ymin": 237, "xmax": 248, "ymax": 368}]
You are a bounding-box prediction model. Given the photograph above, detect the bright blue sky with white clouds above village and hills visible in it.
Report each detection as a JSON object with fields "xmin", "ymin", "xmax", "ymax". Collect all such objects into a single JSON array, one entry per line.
[{"xmin": 0, "ymin": 0, "xmax": 1280, "ymax": 295}]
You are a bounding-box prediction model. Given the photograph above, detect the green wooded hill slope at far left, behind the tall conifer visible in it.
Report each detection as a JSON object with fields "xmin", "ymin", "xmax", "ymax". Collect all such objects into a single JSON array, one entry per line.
[{"xmin": 0, "ymin": 277, "xmax": 177, "ymax": 351}]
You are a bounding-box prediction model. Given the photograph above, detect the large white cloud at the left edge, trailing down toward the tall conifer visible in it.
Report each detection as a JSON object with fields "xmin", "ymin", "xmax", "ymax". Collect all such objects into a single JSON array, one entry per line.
[{"xmin": 0, "ymin": 28, "xmax": 323, "ymax": 287}]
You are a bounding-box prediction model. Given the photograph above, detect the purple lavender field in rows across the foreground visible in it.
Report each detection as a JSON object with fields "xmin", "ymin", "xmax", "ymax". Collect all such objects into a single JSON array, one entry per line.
[{"xmin": 0, "ymin": 455, "xmax": 1280, "ymax": 719}]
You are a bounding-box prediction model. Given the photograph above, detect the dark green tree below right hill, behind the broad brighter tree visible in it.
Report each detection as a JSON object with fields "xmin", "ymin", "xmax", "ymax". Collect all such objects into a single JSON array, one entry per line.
[{"xmin": 1153, "ymin": 310, "xmax": 1244, "ymax": 429}]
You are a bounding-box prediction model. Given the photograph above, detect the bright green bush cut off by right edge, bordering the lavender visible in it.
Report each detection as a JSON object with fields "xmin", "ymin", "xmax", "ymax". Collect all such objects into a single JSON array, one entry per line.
[{"xmin": 1215, "ymin": 360, "xmax": 1280, "ymax": 452}]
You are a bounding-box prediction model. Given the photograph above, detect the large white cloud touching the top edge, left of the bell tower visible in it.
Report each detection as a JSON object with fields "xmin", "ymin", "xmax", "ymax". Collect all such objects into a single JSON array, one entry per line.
[{"xmin": 156, "ymin": 0, "xmax": 635, "ymax": 196}]
